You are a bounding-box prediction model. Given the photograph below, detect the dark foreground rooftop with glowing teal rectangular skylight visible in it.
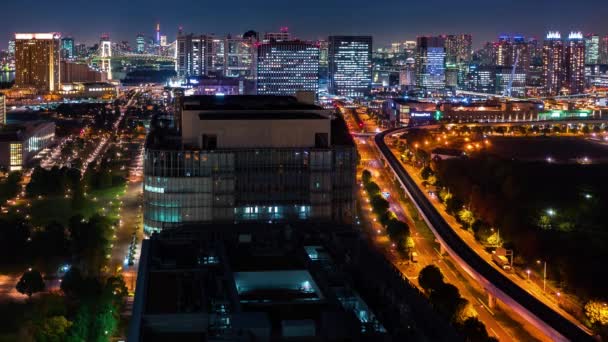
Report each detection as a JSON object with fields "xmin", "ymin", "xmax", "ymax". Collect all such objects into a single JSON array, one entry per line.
[{"xmin": 134, "ymin": 223, "xmax": 382, "ymax": 340}]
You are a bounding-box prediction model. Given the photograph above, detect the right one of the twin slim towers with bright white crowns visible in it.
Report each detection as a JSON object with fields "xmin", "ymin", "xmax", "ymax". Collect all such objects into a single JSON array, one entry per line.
[{"xmin": 564, "ymin": 32, "xmax": 585, "ymax": 94}]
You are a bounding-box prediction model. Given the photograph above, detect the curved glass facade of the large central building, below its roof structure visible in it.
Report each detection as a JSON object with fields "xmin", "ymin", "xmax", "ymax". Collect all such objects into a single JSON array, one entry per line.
[{"xmin": 144, "ymin": 147, "xmax": 356, "ymax": 232}]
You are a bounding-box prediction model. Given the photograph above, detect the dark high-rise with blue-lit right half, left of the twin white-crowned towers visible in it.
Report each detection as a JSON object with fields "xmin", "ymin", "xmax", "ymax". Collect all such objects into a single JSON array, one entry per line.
[{"xmin": 416, "ymin": 37, "xmax": 445, "ymax": 90}]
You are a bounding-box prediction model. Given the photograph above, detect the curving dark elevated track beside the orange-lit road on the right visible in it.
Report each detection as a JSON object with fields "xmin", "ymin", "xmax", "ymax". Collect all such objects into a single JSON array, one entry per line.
[{"xmin": 374, "ymin": 128, "xmax": 593, "ymax": 341}]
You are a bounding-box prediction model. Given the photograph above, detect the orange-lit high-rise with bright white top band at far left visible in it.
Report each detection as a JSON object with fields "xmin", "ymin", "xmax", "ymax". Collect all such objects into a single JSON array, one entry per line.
[{"xmin": 15, "ymin": 33, "xmax": 61, "ymax": 92}]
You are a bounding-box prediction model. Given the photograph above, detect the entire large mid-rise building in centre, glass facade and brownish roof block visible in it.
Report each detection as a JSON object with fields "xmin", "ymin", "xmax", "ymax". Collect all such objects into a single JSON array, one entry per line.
[{"xmin": 144, "ymin": 95, "xmax": 356, "ymax": 233}]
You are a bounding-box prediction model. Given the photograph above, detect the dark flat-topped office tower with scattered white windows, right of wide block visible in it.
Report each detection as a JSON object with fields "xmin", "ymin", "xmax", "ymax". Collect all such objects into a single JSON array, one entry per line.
[{"xmin": 328, "ymin": 36, "xmax": 372, "ymax": 97}]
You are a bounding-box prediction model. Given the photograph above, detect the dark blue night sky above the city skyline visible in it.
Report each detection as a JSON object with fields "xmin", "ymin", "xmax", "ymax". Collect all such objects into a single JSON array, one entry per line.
[{"xmin": 0, "ymin": 0, "xmax": 608, "ymax": 49}]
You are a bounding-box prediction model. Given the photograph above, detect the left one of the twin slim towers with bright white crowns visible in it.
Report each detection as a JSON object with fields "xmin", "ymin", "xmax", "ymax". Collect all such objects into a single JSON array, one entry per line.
[{"xmin": 543, "ymin": 32, "xmax": 564, "ymax": 96}]
